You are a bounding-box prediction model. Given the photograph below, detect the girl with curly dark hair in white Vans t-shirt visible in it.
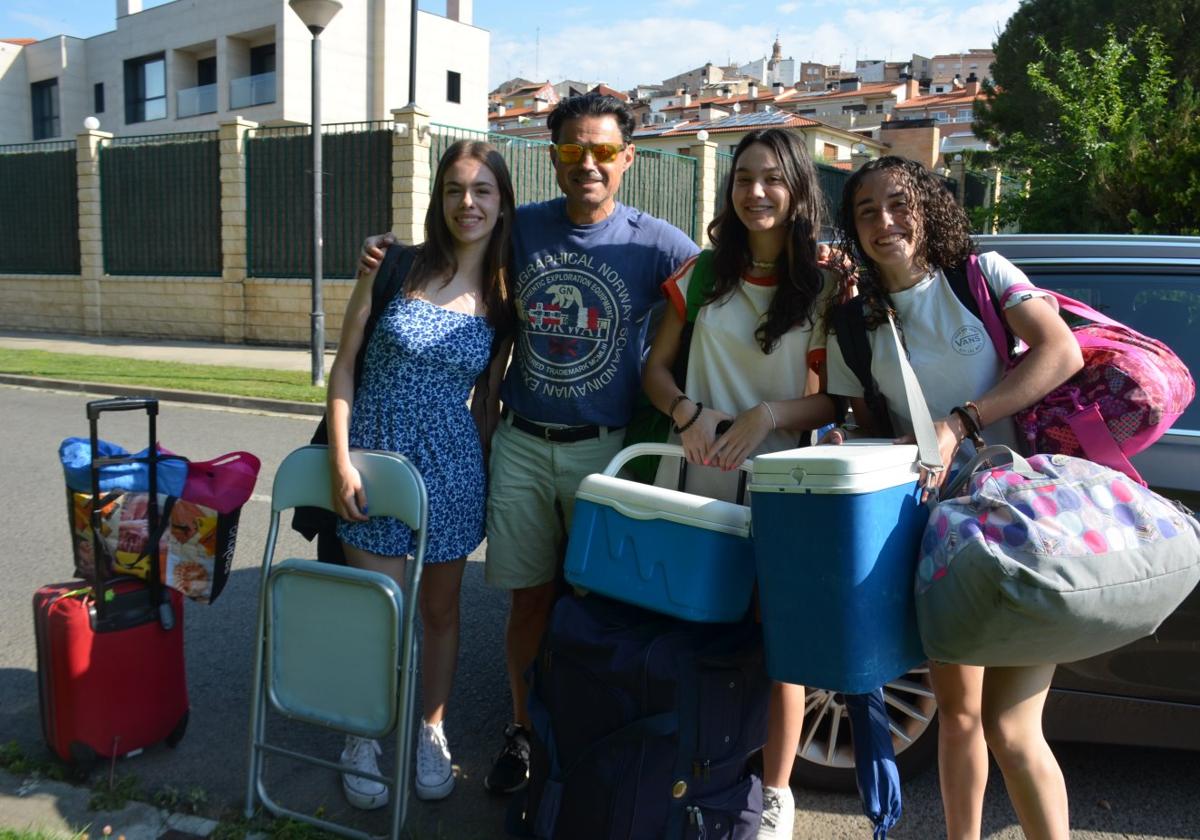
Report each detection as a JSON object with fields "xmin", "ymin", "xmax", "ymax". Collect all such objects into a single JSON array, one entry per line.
[{"xmin": 828, "ymin": 157, "xmax": 1082, "ymax": 840}]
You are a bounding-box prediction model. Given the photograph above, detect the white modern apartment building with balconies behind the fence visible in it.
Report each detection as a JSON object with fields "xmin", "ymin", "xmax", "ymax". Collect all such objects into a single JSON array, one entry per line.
[{"xmin": 0, "ymin": 0, "xmax": 490, "ymax": 144}]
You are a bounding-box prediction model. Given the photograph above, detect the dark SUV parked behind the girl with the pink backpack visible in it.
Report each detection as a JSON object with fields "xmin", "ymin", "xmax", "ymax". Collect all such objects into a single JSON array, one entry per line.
[{"xmin": 793, "ymin": 234, "xmax": 1200, "ymax": 791}]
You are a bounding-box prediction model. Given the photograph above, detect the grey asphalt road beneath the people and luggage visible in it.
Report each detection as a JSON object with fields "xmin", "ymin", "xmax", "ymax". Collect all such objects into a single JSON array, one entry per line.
[{"xmin": 0, "ymin": 386, "xmax": 1200, "ymax": 840}]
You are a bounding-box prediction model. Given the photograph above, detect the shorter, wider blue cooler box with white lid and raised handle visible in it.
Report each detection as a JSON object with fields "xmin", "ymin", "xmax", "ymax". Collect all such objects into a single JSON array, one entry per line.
[{"xmin": 565, "ymin": 444, "xmax": 755, "ymax": 622}]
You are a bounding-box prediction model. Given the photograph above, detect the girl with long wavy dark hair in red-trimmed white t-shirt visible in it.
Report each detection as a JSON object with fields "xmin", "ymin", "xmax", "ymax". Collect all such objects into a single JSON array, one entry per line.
[{"xmin": 643, "ymin": 128, "xmax": 836, "ymax": 839}]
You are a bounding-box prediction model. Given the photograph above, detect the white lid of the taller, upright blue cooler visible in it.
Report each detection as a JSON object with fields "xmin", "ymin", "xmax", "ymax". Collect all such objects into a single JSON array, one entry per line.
[{"xmin": 750, "ymin": 438, "xmax": 920, "ymax": 493}]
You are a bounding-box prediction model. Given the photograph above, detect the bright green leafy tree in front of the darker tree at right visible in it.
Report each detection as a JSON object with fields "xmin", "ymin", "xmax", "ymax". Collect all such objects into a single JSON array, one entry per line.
[{"xmin": 988, "ymin": 27, "xmax": 1200, "ymax": 234}]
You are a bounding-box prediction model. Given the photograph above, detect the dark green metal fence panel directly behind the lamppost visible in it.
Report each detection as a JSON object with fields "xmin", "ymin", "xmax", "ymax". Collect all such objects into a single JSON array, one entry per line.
[{"xmin": 246, "ymin": 122, "xmax": 391, "ymax": 277}]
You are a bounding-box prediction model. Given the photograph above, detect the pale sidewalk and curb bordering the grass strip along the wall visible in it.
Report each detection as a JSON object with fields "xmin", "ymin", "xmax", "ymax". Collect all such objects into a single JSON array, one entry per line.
[{"xmin": 0, "ymin": 330, "xmax": 334, "ymax": 417}]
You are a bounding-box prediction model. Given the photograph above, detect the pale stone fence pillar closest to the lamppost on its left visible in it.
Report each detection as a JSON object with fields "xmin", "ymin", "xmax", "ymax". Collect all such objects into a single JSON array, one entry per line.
[{"xmin": 217, "ymin": 116, "xmax": 258, "ymax": 344}]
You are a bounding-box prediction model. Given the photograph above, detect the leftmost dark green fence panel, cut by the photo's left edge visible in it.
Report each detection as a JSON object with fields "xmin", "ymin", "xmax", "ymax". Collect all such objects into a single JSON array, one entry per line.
[{"xmin": 0, "ymin": 140, "xmax": 79, "ymax": 274}]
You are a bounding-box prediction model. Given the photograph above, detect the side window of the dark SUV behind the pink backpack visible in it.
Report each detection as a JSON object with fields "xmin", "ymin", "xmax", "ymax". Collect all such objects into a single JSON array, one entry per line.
[{"xmin": 1021, "ymin": 266, "xmax": 1200, "ymax": 431}]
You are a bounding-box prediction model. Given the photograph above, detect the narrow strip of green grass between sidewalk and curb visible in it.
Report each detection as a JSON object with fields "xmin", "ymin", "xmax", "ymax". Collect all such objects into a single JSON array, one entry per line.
[{"xmin": 0, "ymin": 348, "xmax": 325, "ymax": 400}]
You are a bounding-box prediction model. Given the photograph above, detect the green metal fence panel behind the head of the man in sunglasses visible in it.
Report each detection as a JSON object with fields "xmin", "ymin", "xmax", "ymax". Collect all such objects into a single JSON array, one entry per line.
[{"xmin": 430, "ymin": 124, "xmax": 698, "ymax": 233}]
